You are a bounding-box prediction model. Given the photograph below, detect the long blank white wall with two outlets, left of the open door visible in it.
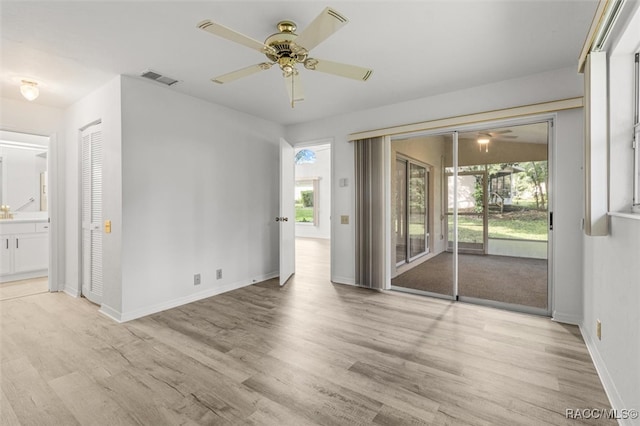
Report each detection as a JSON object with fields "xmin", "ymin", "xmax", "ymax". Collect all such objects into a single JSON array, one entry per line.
[{"xmin": 114, "ymin": 77, "xmax": 283, "ymax": 320}]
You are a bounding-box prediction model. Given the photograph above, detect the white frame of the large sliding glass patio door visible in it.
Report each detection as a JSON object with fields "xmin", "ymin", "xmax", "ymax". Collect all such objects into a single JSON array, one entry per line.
[{"xmin": 385, "ymin": 112, "xmax": 558, "ymax": 317}]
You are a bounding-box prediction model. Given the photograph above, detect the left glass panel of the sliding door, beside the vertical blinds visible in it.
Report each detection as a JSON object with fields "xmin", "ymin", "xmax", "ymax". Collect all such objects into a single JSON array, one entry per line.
[{"xmin": 391, "ymin": 134, "xmax": 454, "ymax": 298}]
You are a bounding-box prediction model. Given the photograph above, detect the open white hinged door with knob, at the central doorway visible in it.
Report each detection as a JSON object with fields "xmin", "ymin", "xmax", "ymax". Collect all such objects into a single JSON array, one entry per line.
[{"xmin": 276, "ymin": 138, "xmax": 296, "ymax": 285}]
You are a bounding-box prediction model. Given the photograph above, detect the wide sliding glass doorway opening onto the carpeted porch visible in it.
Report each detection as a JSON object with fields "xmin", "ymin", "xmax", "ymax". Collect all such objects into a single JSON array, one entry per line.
[{"xmin": 390, "ymin": 120, "xmax": 551, "ymax": 315}]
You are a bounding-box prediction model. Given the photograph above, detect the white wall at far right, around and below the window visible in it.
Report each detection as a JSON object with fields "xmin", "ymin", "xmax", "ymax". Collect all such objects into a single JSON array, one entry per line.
[{"xmin": 581, "ymin": 3, "xmax": 640, "ymax": 425}]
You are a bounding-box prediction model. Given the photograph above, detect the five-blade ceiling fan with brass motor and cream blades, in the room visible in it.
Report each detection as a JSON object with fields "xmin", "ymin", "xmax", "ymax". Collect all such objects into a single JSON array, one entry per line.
[{"xmin": 198, "ymin": 7, "xmax": 373, "ymax": 108}]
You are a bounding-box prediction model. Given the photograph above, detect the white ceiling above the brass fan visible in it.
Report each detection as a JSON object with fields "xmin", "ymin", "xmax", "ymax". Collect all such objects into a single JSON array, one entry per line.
[{"xmin": 0, "ymin": 0, "xmax": 597, "ymax": 125}]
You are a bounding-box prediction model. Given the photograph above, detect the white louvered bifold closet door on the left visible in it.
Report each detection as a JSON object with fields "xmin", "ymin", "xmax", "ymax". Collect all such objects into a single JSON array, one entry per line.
[{"xmin": 82, "ymin": 124, "xmax": 103, "ymax": 304}]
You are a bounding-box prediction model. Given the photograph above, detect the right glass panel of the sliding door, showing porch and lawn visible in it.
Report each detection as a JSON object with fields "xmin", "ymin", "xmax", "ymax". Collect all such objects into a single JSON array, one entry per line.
[{"xmin": 458, "ymin": 122, "xmax": 549, "ymax": 312}]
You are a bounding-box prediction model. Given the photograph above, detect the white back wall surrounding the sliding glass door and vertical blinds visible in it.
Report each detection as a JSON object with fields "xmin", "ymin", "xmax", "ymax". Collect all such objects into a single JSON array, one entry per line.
[{"xmin": 286, "ymin": 67, "xmax": 583, "ymax": 312}]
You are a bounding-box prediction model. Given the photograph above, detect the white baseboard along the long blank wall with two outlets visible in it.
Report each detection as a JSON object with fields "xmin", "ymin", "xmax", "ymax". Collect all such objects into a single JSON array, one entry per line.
[{"xmin": 110, "ymin": 272, "xmax": 280, "ymax": 322}]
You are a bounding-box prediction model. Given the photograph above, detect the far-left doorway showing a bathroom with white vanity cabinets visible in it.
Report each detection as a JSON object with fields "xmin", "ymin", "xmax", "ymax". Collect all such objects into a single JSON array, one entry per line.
[{"xmin": 0, "ymin": 131, "xmax": 51, "ymax": 299}]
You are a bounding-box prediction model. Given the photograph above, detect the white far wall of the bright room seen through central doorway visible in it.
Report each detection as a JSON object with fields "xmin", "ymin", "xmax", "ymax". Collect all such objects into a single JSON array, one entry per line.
[{"xmin": 295, "ymin": 144, "xmax": 331, "ymax": 239}]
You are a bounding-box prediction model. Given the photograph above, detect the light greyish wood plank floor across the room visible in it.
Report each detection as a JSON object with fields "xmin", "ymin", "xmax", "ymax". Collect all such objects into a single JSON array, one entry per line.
[{"xmin": 0, "ymin": 239, "xmax": 615, "ymax": 425}]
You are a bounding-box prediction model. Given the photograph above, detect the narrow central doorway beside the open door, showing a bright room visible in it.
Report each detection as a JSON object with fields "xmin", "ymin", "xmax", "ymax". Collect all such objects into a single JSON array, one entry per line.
[{"xmin": 294, "ymin": 141, "xmax": 333, "ymax": 279}]
